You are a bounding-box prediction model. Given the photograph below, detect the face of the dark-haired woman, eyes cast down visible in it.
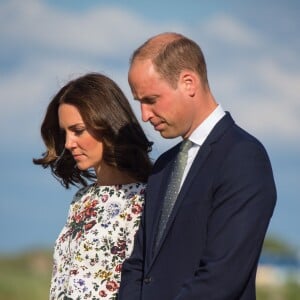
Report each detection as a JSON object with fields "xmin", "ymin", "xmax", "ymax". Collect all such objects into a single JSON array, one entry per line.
[{"xmin": 58, "ymin": 103, "xmax": 103, "ymax": 172}]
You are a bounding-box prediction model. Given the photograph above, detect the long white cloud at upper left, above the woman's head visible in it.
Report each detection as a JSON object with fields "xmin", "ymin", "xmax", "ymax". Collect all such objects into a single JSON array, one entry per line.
[{"xmin": 0, "ymin": 0, "xmax": 172, "ymax": 57}]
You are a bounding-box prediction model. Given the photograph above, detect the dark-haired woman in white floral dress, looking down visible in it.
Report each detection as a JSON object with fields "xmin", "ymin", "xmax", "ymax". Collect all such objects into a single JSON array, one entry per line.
[{"xmin": 33, "ymin": 73, "xmax": 151, "ymax": 300}]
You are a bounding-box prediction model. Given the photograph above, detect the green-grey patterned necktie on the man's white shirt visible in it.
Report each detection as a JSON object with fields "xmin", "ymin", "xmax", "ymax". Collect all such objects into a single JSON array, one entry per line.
[{"xmin": 156, "ymin": 139, "xmax": 193, "ymax": 247}]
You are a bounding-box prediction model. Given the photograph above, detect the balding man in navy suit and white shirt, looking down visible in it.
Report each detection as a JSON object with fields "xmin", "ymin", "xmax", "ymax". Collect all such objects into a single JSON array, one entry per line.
[{"xmin": 118, "ymin": 33, "xmax": 276, "ymax": 300}]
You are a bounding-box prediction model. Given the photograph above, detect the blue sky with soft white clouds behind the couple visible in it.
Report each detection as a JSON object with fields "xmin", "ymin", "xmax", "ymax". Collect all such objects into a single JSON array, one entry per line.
[{"xmin": 0, "ymin": 0, "xmax": 300, "ymax": 252}]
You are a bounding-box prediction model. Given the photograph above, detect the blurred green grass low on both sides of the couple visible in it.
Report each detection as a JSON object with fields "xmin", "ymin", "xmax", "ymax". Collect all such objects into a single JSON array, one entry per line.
[{"xmin": 0, "ymin": 250, "xmax": 300, "ymax": 300}]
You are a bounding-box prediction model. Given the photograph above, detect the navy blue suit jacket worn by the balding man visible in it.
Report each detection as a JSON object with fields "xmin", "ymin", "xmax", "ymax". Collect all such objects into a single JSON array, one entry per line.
[{"xmin": 118, "ymin": 113, "xmax": 276, "ymax": 300}]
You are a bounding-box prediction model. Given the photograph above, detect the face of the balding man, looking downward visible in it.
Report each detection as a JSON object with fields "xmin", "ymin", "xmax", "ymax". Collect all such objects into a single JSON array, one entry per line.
[{"xmin": 128, "ymin": 60, "xmax": 192, "ymax": 138}]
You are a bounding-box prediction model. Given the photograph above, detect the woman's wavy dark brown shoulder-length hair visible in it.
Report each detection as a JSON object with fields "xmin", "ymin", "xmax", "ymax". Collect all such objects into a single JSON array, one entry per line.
[{"xmin": 33, "ymin": 73, "xmax": 152, "ymax": 188}]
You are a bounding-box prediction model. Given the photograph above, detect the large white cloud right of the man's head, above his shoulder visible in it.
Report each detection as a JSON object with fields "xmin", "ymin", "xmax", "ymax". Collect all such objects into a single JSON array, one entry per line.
[{"xmin": 213, "ymin": 58, "xmax": 300, "ymax": 142}]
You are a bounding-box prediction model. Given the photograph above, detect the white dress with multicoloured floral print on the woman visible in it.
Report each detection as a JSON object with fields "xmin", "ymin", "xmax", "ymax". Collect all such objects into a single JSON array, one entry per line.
[{"xmin": 50, "ymin": 183, "xmax": 145, "ymax": 300}]
